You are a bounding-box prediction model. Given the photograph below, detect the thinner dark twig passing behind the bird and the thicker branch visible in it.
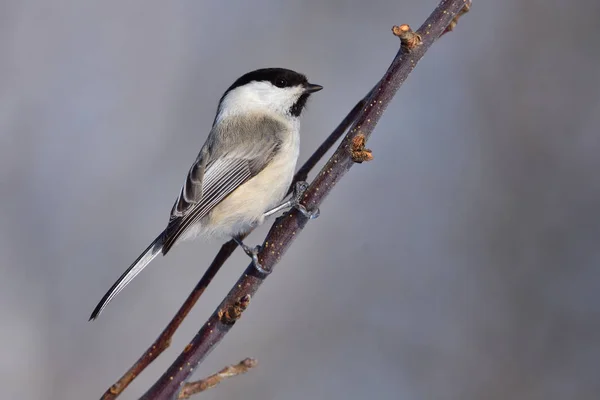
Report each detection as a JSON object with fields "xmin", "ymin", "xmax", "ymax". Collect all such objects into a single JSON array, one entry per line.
[{"xmin": 101, "ymin": 86, "xmax": 371, "ymax": 400}]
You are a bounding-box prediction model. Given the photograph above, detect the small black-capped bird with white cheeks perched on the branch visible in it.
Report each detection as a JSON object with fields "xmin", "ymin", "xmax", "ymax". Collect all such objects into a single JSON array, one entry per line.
[{"xmin": 90, "ymin": 68, "xmax": 323, "ymax": 320}]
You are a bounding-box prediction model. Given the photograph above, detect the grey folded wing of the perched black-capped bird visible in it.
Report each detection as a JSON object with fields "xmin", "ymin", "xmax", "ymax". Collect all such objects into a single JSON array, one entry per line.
[{"xmin": 162, "ymin": 118, "xmax": 285, "ymax": 254}]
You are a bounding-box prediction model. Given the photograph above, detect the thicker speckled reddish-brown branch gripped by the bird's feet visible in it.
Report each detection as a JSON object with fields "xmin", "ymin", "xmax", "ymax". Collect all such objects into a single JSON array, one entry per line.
[{"xmin": 142, "ymin": 0, "xmax": 471, "ymax": 400}]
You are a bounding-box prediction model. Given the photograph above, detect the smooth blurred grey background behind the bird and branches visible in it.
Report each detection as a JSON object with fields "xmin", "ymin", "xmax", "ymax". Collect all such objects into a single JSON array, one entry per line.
[{"xmin": 0, "ymin": 0, "xmax": 600, "ymax": 400}]
